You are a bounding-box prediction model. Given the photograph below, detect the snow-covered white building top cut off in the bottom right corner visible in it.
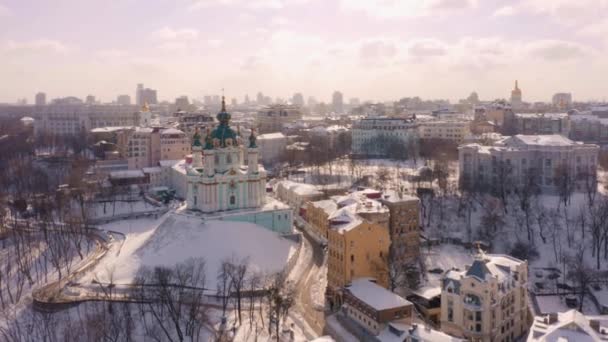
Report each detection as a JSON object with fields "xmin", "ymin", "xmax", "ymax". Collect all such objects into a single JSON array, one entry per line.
[{"xmin": 527, "ymin": 309, "xmax": 608, "ymax": 342}]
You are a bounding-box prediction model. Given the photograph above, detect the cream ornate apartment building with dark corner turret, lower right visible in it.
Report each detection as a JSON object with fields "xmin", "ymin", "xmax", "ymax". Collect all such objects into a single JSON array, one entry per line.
[{"xmin": 441, "ymin": 252, "xmax": 530, "ymax": 342}]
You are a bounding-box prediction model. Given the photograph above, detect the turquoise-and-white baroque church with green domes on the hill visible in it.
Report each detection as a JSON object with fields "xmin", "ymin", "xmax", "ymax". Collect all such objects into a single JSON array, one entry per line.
[{"xmin": 186, "ymin": 96, "xmax": 266, "ymax": 213}]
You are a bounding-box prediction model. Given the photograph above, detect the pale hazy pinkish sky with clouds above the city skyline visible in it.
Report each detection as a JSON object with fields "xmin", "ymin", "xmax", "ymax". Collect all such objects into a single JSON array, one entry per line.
[{"xmin": 0, "ymin": 0, "xmax": 608, "ymax": 103}]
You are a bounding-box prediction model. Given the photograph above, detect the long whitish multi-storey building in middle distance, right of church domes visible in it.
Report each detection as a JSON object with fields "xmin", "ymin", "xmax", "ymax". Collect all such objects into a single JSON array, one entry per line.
[{"xmin": 352, "ymin": 117, "xmax": 418, "ymax": 156}]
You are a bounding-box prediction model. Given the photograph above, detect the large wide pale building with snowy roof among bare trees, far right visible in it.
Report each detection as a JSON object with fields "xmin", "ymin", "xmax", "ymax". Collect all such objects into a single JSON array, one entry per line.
[{"xmin": 458, "ymin": 135, "xmax": 599, "ymax": 192}]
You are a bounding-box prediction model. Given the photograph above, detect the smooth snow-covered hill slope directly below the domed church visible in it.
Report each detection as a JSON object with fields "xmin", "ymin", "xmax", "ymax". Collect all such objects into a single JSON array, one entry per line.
[{"xmin": 81, "ymin": 213, "xmax": 296, "ymax": 288}]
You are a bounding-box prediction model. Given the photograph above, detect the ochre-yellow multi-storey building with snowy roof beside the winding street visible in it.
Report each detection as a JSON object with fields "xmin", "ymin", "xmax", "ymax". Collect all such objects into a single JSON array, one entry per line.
[{"xmin": 327, "ymin": 203, "xmax": 390, "ymax": 303}]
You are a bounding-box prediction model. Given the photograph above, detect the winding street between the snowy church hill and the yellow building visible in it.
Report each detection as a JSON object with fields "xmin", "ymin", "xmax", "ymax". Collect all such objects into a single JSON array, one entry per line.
[{"xmin": 296, "ymin": 216, "xmax": 326, "ymax": 336}]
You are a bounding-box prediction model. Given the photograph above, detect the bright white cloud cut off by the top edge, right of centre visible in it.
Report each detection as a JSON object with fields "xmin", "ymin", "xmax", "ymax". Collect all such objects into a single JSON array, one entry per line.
[{"xmin": 340, "ymin": 0, "xmax": 477, "ymax": 18}]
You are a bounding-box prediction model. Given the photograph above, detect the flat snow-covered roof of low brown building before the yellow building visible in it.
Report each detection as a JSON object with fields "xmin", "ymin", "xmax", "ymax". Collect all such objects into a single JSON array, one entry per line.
[{"xmin": 346, "ymin": 278, "xmax": 412, "ymax": 311}]
